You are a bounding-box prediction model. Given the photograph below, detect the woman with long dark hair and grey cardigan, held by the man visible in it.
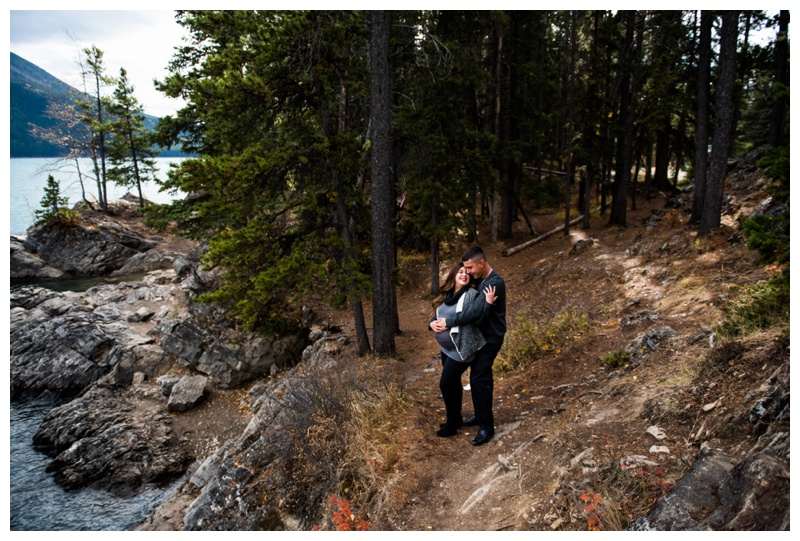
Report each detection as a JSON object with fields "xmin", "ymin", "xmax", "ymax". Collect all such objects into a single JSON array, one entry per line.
[{"xmin": 429, "ymin": 261, "xmax": 495, "ymax": 438}]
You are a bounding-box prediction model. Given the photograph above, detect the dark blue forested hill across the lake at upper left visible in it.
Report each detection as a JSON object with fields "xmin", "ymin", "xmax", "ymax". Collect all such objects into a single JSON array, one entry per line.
[{"xmin": 9, "ymin": 53, "xmax": 176, "ymax": 158}]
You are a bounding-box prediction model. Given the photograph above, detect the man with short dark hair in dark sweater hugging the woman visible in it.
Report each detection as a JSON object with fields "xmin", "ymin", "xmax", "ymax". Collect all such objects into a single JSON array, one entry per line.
[{"xmin": 431, "ymin": 246, "xmax": 506, "ymax": 445}]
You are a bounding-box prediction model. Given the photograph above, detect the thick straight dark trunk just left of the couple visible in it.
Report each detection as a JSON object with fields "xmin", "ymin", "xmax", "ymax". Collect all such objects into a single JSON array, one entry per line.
[{"xmin": 370, "ymin": 11, "xmax": 396, "ymax": 356}]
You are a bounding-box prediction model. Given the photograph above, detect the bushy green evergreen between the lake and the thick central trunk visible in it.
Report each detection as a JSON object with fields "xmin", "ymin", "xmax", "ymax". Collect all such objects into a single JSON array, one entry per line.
[{"xmin": 151, "ymin": 11, "xmax": 378, "ymax": 334}]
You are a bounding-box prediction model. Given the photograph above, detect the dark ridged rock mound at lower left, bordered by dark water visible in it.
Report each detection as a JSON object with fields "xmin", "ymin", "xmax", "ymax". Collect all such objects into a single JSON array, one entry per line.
[{"xmin": 33, "ymin": 385, "xmax": 192, "ymax": 494}]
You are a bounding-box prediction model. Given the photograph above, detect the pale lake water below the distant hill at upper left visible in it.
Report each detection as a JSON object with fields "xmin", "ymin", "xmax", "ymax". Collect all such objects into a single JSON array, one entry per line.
[{"xmin": 8, "ymin": 158, "xmax": 186, "ymax": 235}]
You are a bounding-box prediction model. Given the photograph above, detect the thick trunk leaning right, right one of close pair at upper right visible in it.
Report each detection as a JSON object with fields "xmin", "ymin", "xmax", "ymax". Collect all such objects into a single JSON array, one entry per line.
[{"xmin": 697, "ymin": 11, "xmax": 739, "ymax": 236}]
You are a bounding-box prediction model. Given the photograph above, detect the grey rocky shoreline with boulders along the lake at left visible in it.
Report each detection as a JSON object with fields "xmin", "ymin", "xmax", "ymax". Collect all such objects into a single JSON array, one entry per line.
[{"xmin": 10, "ymin": 202, "xmax": 346, "ymax": 530}]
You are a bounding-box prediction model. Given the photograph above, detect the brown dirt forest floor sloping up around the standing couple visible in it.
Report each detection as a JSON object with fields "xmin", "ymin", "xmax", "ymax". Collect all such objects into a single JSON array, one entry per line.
[{"xmin": 133, "ymin": 161, "xmax": 788, "ymax": 531}]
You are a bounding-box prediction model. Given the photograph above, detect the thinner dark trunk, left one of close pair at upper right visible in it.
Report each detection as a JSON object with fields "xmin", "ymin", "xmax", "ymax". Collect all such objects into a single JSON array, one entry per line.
[{"xmin": 689, "ymin": 10, "xmax": 714, "ymax": 225}]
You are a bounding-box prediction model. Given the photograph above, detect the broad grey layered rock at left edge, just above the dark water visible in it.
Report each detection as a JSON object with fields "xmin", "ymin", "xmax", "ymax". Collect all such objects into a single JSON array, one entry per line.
[{"xmin": 10, "ymin": 275, "xmax": 176, "ymax": 400}]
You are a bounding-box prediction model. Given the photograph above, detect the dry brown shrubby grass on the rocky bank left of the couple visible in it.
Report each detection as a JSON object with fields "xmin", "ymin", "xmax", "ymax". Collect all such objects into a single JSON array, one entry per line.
[{"xmin": 275, "ymin": 357, "xmax": 408, "ymax": 530}]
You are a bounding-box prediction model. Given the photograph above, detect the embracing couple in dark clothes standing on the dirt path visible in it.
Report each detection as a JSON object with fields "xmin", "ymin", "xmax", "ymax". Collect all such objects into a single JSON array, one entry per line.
[{"xmin": 429, "ymin": 246, "xmax": 506, "ymax": 445}]
